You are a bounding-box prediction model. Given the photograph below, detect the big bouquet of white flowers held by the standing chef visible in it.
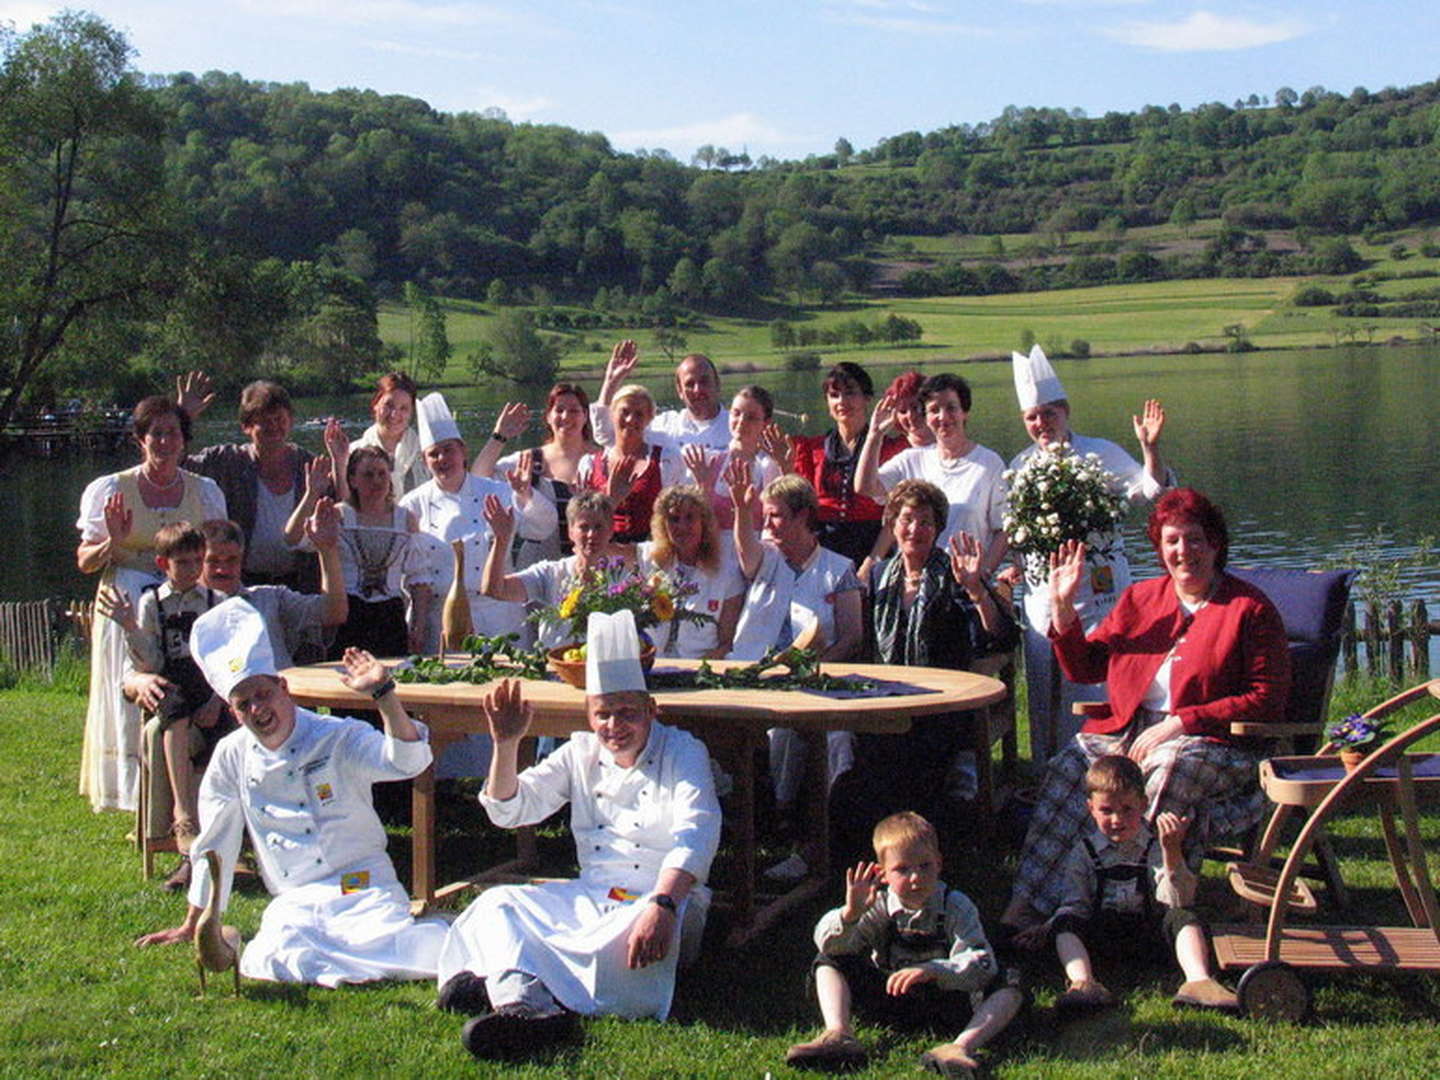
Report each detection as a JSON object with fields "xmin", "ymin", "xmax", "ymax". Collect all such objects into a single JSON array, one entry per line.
[{"xmin": 1005, "ymin": 445, "xmax": 1126, "ymax": 585}]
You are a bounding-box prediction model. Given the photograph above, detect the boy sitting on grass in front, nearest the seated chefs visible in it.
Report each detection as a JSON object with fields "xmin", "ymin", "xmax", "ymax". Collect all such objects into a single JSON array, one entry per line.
[{"xmin": 785, "ymin": 811, "xmax": 1022, "ymax": 1077}]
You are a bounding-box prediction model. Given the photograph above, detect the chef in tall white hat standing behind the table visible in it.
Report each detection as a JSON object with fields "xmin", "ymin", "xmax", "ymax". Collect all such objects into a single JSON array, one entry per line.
[{"xmin": 400, "ymin": 393, "xmax": 557, "ymax": 651}]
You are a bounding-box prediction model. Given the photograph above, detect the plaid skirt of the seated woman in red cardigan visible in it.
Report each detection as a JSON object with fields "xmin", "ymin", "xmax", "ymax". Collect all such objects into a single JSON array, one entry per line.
[{"xmin": 1012, "ymin": 714, "xmax": 1266, "ymax": 917}]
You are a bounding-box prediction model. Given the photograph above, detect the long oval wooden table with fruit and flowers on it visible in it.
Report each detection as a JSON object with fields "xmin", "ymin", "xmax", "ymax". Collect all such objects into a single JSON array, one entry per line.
[{"xmin": 282, "ymin": 660, "xmax": 1005, "ymax": 945}]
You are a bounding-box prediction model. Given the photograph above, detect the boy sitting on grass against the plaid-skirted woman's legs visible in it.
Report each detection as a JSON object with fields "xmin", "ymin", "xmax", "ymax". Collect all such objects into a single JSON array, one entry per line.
[{"xmin": 1035, "ymin": 755, "xmax": 1238, "ymax": 1012}]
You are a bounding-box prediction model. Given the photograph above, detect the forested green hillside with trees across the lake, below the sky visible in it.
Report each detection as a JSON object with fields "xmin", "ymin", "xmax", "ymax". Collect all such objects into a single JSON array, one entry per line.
[{"xmin": 8, "ymin": 12, "xmax": 1440, "ymax": 426}]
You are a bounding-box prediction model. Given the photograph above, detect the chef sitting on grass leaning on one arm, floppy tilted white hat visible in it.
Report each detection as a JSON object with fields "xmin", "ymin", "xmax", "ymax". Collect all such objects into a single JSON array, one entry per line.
[{"xmin": 137, "ymin": 598, "xmax": 445, "ymax": 986}]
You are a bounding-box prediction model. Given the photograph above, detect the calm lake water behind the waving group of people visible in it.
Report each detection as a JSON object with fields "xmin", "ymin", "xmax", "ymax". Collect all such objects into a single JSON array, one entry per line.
[{"xmin": 8, "ymin": 348, "xmax": 1440, "ymax": 622}]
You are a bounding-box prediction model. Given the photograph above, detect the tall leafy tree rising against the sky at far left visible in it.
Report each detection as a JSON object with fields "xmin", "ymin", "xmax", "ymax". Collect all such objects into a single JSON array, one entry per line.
[{"xmin": 0, "ymin": 12, "xmax": 177, "ymax": 429}]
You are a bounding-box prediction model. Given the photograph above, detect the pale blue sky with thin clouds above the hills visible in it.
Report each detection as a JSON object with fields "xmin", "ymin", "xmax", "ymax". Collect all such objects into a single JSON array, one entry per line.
[{"xmin": 0, "ymin": 0, "xmax": 1440, "ymax": 160}]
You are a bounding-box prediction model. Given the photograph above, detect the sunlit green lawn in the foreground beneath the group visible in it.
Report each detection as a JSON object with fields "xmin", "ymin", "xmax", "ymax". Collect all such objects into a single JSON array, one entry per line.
[{"xmin": 0, "ymin": 673, "xmax": 1440, "ymax": 1080}]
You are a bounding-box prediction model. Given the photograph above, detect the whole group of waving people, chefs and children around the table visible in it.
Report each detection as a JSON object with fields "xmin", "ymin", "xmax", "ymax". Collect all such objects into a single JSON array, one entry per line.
[{"xmin": 70, "ymin": 341, "xmax": 1289, "ymax": 1074}]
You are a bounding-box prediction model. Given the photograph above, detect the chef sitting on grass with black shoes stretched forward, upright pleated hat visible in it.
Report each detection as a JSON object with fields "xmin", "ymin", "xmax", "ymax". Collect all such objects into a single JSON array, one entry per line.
[{"xmin": 438, "ymin": 612, "xmax": 720, "ymax": 1058}]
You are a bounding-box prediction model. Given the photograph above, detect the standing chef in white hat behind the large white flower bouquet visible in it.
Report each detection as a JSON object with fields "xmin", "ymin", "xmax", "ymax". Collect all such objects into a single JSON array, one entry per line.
[{"xmin": 1009, "ymin": 346, "xmax": 1175, "ymax": 762}]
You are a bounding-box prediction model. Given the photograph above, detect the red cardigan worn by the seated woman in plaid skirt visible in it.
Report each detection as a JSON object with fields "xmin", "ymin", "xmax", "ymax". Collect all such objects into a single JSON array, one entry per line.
[{"xmin": 1050, "ymin": 573, "xmax": 1290, "ymax": 740}]
